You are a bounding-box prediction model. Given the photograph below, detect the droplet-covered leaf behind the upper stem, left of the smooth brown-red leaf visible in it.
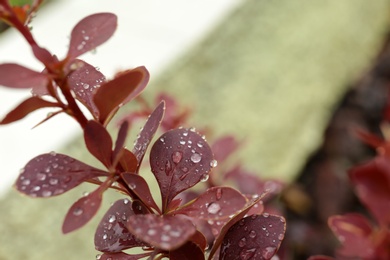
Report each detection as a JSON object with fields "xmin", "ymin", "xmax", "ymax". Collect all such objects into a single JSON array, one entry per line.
[{"xmin": 67, "ymin": 59, "xmax": 106, "ymax": 118}]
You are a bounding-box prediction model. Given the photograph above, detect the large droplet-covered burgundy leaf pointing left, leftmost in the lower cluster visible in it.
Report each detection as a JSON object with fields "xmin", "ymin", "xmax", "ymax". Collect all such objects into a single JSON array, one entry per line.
[{"xmin": 15, "ymin": 152, "xmax": 107, "ymax": 197}]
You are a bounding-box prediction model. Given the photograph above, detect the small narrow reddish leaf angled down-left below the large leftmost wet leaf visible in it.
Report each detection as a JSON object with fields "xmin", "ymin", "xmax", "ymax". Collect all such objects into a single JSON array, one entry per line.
[{"xmin": 62, "ymin": 180, "xmax": 110, "ymax": 234}]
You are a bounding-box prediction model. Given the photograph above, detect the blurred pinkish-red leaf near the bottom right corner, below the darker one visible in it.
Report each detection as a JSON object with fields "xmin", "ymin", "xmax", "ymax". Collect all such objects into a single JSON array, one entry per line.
[{"xmin": 328, "ymin": 213, "xmax": 375, "ymax": 259}]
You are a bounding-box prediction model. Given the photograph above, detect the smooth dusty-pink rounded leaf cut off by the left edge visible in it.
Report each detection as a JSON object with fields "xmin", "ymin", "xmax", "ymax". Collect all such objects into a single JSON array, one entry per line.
[{"xmin": 0, "ymin": 63, "xmax": 49, "ymax": 88}]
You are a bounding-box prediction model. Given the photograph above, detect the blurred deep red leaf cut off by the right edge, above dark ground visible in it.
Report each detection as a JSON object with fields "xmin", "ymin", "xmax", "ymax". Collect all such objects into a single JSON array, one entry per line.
[{"xmin": 349, "ymin": 156, "xmax": 390, "ymax": 225}]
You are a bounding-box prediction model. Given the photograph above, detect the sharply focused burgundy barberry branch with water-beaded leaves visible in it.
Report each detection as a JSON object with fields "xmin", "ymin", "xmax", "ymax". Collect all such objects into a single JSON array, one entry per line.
[{"xmin": 0, "ymin": 0, "xmax": 286, "ymax": 260}]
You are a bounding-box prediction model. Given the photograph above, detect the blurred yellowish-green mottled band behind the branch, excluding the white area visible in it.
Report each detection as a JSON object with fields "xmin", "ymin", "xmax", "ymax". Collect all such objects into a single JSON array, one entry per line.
[{"xmin": 0, "ymin": 0, "xmax": 390, "ymax": 260}]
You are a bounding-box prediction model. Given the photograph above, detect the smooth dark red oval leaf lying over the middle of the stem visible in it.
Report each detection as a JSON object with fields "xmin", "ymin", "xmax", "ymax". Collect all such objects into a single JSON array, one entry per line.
[{"xmin": 84, "ymin": 120, "xmax": 112, "ymax": 168}]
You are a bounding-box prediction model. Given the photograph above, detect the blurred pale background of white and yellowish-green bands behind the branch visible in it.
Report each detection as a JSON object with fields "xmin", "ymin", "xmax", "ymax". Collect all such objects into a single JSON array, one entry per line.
[{"xmin": 0, "ymin": 0, "xmax": 390, "ymax": 260}]
